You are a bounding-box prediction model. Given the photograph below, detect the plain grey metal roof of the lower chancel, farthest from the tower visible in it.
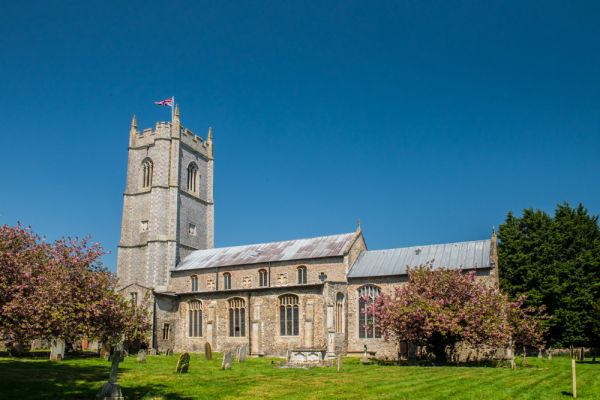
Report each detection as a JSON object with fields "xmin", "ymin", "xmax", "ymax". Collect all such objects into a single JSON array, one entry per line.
[{"xmin": 348, "ymin": 239, "xmax": 491, "ymax": 278}]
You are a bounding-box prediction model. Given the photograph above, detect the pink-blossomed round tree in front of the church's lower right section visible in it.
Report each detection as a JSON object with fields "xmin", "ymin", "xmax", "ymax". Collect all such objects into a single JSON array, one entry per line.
[{"xmin": 373, "ymin": 266, "xmax": 542, "ymax": 362}]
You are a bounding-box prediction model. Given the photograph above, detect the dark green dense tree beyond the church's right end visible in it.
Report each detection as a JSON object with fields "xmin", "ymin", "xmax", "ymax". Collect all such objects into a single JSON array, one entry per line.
[{"xmin": 498, "ymin": 203, "xmax": 600, "ymax": 347}]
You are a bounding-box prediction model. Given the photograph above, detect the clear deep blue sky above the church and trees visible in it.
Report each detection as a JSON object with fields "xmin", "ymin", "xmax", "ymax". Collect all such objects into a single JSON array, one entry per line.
[{"xmin": 0, "ymin": 0, "xmax": 600, "ymax": 269}]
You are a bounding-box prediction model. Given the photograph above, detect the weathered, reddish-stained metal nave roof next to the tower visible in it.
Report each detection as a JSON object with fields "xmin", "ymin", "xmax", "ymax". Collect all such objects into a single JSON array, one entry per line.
[{"xmin": 172, "ymin": 232, "xmax": 357, "ymax": 271}]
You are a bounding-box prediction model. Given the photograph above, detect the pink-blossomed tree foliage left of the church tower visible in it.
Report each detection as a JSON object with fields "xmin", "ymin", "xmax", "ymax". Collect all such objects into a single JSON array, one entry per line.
[{"xmin": 0, "ymin": 225, "xmax": 150, "ymax": 350}]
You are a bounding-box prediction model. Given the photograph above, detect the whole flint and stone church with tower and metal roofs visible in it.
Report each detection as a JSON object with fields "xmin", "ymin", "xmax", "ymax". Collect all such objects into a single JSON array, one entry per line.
[{"xmin": 117, "ymin": 106, "xmax": 498, "ymax": 357}]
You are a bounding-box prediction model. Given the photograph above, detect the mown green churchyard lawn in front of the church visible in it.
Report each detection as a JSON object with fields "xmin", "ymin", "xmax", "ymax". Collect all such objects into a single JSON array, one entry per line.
[{"xmin": 0, "ymin": 354, "xmax": 600, "ymax": 400}]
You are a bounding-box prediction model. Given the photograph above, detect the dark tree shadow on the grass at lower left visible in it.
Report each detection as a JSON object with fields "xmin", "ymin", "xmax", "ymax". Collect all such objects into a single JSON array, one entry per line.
[{"xmin": 0, "ymin": 358, "xmax": 190, "ymax": 400}]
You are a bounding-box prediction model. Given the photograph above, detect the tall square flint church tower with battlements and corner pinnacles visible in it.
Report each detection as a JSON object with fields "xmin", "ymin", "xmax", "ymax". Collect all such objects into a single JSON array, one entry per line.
[{"xmin": 117, "ymin": 106, "xmax": 214, "ymax": 290}]
